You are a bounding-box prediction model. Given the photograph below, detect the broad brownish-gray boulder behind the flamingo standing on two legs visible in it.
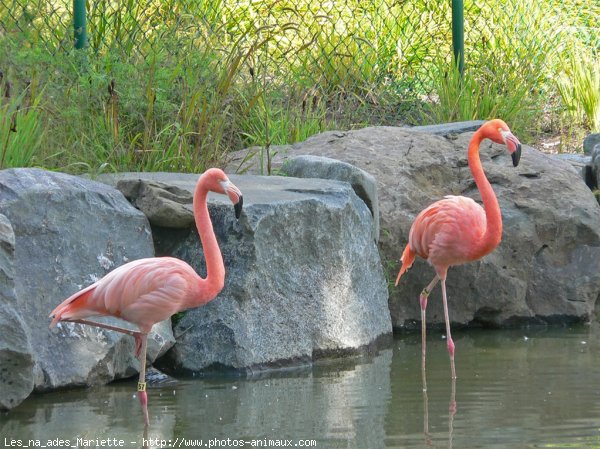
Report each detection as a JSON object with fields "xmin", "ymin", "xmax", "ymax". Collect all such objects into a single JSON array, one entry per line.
[{"xmin": 227, "ymin": 127, "xmax": 600, "ymax": 328}]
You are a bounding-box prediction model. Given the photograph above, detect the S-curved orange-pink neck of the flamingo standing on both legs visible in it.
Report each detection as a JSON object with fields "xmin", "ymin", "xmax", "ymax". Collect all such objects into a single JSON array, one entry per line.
[{"xmin": 468, "ymin": 131, "xmax": 502, "ymax": 259}]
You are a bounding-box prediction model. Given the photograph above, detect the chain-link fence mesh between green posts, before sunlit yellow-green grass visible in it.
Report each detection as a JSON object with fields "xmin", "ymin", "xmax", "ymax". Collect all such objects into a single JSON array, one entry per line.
[{"xmin": 0, "ymin": 0, "xmax": 600, "ymax": 121}]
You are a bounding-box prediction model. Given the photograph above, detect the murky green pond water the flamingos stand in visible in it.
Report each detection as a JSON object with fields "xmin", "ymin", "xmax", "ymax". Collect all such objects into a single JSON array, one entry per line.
[{"xmin": 0, "ymin": 325, "xmax": 600, "ymax": 449}]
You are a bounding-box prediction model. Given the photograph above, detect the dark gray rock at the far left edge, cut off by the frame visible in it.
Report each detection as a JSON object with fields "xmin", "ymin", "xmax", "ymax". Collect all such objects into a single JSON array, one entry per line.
[{"xmin": 0, "ymin": 215, "xmax": 34, "ymax": 411}]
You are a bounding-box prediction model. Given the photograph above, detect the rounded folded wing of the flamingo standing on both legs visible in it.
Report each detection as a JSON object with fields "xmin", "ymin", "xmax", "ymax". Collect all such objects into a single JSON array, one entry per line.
[{"xmin": 409, "ymin": 195, "xmax": 486, "ymax": 268}]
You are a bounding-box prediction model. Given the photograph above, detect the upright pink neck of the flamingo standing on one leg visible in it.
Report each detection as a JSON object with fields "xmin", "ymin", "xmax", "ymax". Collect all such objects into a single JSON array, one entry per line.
[{"xmin": 193, "ymin": 180, "xmax": 225, "ymax": 306}]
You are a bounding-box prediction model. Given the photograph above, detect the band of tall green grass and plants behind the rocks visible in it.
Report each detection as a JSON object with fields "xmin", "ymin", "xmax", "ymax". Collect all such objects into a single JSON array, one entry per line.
[{"xmin": 0, "ymin": 0, "xmax": 600, "ymax": 173}]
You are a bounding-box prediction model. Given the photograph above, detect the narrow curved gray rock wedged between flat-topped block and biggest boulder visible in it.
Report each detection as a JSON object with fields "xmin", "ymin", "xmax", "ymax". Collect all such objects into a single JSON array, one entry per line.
[{"xmin": 281, "ymin": 155, "xmax": 379, "ymax": 242}]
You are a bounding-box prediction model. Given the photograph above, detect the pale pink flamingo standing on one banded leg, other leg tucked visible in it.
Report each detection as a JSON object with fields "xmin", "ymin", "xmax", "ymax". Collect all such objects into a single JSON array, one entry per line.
[{"xmin": 50, "ymin": 168, "xmax": 243, "ymax": 426}]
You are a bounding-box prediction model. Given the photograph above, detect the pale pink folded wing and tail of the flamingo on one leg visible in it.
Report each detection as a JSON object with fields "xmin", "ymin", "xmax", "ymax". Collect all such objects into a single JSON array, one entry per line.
[{"xmin": 50, "ymin": 257, "xmax": 201, "ymax": 332}]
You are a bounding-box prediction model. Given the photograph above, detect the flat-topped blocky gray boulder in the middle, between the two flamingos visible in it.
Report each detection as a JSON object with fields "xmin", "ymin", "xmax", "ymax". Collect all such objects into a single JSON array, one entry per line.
[{"xmin": 101, "ymin": 173, "xmax": 392, "ymax": 373}]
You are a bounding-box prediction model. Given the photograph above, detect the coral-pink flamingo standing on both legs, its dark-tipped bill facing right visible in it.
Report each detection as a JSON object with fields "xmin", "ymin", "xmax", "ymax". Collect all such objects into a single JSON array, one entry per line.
[{"xmin": 395, "ymin": 119, "xmax": 521, "ymax": 378}]
